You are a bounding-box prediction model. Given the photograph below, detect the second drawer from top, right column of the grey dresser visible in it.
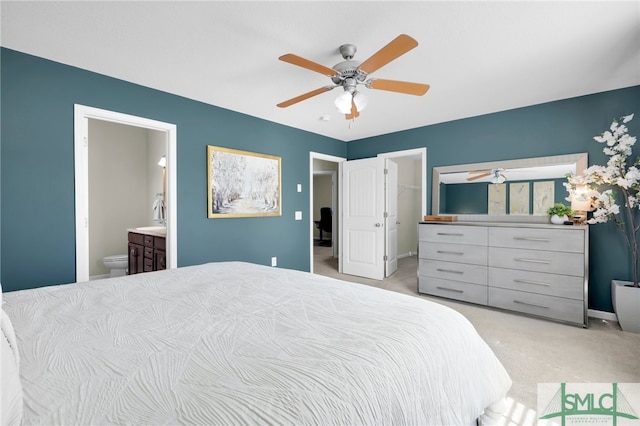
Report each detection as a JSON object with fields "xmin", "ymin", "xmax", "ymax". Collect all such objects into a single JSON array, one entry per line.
[{"xmin": 489, "ymin": 247, "xmax": 584, "ymax": 277}]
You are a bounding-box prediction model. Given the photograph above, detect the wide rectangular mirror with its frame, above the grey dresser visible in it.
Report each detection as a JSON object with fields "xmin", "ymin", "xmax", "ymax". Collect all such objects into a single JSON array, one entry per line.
[{"xmin": 431, "ymin": 153, "xmax": 587, "ymax": 222}]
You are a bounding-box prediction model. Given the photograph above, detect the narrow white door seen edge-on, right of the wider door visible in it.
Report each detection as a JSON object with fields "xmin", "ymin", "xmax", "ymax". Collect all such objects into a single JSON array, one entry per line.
[{"xmin": 384, "ymin": 159, "xmax": 398, "ymax": 277}]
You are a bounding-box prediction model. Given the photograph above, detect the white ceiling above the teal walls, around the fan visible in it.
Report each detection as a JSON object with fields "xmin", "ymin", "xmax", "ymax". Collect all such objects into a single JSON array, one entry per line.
[{"xmin": 0, "ymin": 1, "xmax": 640, "ymax": 141}]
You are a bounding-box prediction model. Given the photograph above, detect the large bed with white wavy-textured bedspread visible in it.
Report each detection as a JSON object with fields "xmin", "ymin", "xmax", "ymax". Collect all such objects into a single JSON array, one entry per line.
[{"xmin": 2, "ymin": 262, "xmax": 511, "ymax": 425}]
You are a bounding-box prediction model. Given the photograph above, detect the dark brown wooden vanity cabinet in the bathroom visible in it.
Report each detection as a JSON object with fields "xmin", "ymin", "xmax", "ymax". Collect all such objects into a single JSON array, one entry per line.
[{"xmin": 129, "ymin": 232, "xmax": 167, "ymax": 275}]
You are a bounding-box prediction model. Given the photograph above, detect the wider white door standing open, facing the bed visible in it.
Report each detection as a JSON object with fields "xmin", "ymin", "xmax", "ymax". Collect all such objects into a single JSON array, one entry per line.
[{"xmin": 339, "ymin": 158, "xmax": 386, "ymax": 280}]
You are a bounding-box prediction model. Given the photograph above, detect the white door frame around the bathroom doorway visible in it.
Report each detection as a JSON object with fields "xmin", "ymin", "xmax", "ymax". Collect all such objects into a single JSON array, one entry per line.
[{"xmin": 73, "ymin": 104, "xmax": 178, "ymax": 282}]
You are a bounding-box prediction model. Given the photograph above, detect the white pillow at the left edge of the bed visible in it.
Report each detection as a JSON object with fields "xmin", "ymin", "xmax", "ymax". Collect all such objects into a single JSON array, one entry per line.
[{"xmin": 0, "ymin": 310, "xmax": 23, "ymax": 425}]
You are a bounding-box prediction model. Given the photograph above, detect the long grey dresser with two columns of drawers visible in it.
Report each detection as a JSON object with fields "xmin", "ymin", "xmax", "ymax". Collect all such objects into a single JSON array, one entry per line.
[{"xmin": 418, "ymin": 222, "xmax": 589, "ymax": 327}]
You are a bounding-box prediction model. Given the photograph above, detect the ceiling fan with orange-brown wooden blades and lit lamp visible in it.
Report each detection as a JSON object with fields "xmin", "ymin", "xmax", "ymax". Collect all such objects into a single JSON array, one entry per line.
[{"xmin": 277, "ymin": 34, "xmax": 429, "ymax": 120}]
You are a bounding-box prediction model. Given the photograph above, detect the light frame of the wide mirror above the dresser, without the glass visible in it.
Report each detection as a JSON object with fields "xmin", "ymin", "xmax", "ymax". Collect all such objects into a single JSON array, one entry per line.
[{"xmin": 431, "ymin": 152, "xmax": 588, "ymax": 223}]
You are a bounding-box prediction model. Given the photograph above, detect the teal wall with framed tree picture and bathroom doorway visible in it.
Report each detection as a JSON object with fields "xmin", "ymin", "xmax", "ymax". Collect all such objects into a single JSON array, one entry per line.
[{"xmin": 0, "ymin": 49, "xmax": 347, "ymax": 291}]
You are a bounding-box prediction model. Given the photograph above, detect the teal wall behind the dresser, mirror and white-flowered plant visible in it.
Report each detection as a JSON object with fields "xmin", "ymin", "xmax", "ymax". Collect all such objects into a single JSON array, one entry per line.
[{"xmin": 348, "ymin": 86, "xmax": 640, "ymax": 312}]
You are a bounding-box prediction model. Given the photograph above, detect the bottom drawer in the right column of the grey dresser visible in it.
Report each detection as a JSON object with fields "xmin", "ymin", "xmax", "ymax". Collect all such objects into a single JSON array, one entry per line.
[{"xmin": 488, "ymin": 287, "xmax": 584, "ymax": 324}]
